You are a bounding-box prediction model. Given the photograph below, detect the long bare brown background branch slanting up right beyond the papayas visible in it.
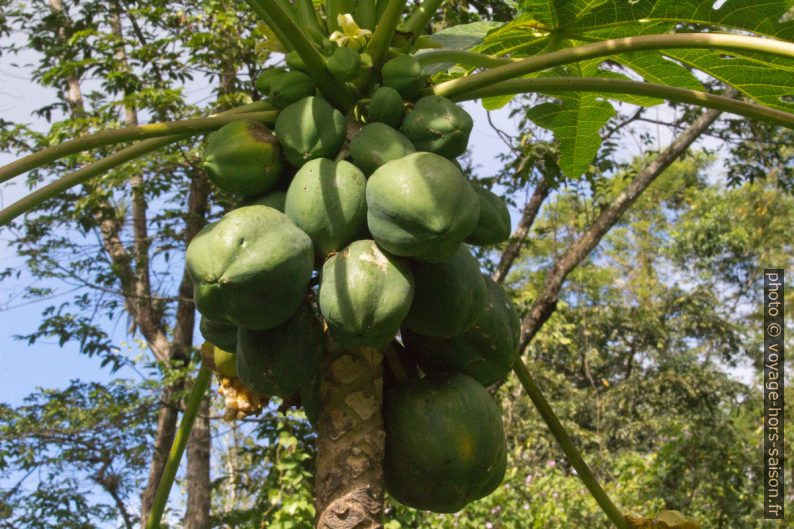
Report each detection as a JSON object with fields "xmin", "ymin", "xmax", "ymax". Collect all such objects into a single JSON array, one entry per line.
[{"xmin": 519, "ymin": 101, "xmax": 721, "ymax": 351}]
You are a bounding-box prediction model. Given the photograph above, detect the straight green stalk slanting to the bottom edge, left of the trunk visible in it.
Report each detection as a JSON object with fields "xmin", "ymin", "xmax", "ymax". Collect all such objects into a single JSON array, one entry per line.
[{"xmin": 146, "ymin": 365, "xmax": 212, "ymax": 529}]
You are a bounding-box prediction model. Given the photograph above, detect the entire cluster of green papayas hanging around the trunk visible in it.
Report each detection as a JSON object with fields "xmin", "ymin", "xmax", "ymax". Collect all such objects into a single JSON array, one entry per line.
[{"xmin": 187, "ymin": 48, "xmax": 519, "ymax": 512}]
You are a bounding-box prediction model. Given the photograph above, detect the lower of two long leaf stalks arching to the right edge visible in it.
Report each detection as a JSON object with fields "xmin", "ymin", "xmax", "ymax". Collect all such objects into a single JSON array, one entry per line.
[{"xmin": 452, "ymin": 77, "xmax": 794, "ymax": 129}]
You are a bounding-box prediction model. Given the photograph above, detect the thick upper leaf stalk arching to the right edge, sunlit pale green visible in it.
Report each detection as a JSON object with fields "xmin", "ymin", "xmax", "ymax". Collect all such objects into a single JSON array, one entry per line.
[{"xmin": 433, "ymin": 33, "xmax": 794, "ymax": 98}]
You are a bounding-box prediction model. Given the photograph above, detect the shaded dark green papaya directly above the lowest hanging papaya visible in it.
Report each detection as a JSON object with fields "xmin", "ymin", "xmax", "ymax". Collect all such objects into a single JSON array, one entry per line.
[{"xmin": 401, "ymin": 276, "xmax": 521, "ymax": 386}]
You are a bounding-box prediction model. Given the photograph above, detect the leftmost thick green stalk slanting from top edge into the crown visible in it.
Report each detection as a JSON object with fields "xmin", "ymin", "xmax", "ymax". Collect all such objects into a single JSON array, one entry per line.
[{"xmin": 245, "ymin": 0, "xmax": 353, "ymax": 111}]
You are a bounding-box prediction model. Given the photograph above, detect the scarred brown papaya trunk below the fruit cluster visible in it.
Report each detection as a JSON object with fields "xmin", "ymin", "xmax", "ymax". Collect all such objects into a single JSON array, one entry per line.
[{"xmin": 314, "ymin": 340, "xmax": 386, "ymax": 529}]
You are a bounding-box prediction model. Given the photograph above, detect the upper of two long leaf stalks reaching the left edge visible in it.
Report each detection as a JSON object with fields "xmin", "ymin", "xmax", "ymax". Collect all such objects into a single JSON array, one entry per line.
[{"xmin": 0, "ymin": 105, "xmax": 276, "ymax": 183}]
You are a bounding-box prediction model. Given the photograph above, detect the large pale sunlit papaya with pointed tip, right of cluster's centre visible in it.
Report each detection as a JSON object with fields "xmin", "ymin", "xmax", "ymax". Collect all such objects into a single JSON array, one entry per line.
[{"xmin": 367, "ymin": 152, "xmax": 480, "ymax": 263}]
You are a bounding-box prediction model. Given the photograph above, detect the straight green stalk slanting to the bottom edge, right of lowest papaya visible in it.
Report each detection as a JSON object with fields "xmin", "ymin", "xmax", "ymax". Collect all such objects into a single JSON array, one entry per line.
[{"xmin": 513, "ymin": 358, "xmax": 631, "ymax": 529}]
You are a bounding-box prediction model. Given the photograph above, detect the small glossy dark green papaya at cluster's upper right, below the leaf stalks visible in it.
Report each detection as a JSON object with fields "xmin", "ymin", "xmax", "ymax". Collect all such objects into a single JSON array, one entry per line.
[{"xmin": 400, "ymin": 96, "xmax": 474, "ymax": 158}]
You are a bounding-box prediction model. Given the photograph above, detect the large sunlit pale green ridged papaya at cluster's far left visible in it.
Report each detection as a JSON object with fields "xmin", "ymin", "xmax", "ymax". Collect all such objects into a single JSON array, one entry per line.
[{"xmin": 185, "ymin": 205, "xmax": 314, "ymax": 329}]
